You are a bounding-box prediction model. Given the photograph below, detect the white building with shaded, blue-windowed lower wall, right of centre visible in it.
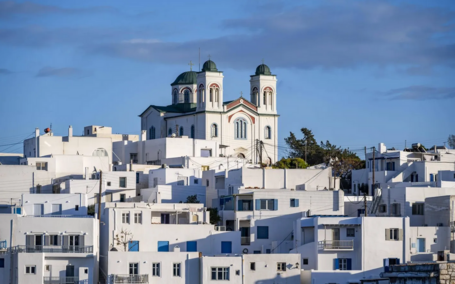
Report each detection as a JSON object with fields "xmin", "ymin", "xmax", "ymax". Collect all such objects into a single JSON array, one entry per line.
[{"xmin": 220, "ymin": 189, "xmax": 344, "ymax": 253}]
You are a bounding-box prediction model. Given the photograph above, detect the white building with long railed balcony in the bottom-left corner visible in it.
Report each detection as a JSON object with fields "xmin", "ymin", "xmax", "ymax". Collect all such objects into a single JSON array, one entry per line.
[{"xmin": 0, "ymin": 194, "xmax": 99, "ymax": 284}]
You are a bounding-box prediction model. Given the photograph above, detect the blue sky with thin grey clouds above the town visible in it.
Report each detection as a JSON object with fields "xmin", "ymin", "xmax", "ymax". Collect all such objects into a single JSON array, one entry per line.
[{"xmin": 0, "ymin": 0, "xmax": 455, "ymax": 158}]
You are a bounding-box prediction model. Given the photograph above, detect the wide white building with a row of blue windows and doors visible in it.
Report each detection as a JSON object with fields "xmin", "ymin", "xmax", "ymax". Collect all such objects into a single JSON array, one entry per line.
[{"xmin": 100, "ymin": 202, "xmax": 241, "ymax": 278}]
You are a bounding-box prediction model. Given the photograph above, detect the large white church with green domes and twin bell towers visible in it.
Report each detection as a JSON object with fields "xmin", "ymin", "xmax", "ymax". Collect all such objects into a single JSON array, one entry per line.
[{"xmin": 139, "ymin": 60, "xmax": 279, "ymax": 164}]
